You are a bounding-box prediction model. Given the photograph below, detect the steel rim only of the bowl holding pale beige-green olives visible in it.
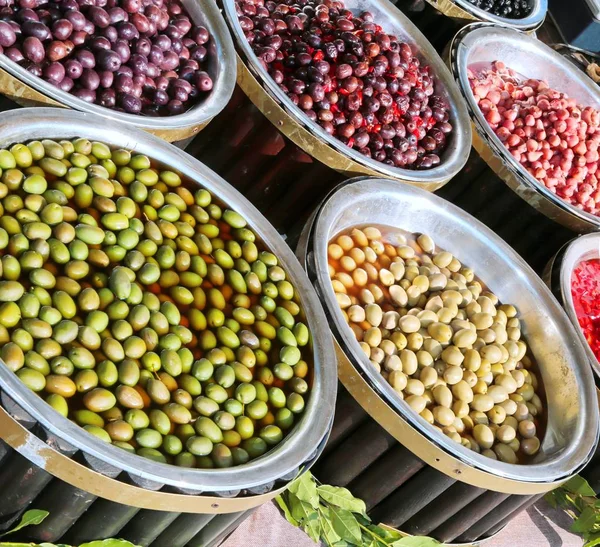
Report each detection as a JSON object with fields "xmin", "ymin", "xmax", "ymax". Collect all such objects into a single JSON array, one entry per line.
[{"xmin": 305, "ymin": 177, "xmax": 599, "ymax": 483}]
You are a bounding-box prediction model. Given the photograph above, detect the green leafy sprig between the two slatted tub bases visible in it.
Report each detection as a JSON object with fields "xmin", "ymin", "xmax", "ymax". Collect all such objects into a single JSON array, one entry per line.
[{"xmin": 275, "ymin": 471, "xmax": 440, "ymax": 547}]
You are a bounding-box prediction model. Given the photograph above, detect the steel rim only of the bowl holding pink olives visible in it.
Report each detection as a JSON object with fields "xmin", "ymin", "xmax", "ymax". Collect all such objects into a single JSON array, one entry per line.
[{"xmin": 450, "ymin": 23, "xmax": 600, "ymax": 231}]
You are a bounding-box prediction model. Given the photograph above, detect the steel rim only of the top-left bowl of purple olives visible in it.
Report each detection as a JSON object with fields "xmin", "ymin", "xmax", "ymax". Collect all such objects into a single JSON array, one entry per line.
[{"xmin": 0, "ymin": 0, "xmax": 237, "ymax": 130}]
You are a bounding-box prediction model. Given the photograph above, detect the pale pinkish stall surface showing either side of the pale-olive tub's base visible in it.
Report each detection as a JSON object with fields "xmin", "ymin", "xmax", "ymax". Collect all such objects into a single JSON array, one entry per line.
[{"xmin": 223, "ymin": 501, "xmax": 583, "ymax": 547}]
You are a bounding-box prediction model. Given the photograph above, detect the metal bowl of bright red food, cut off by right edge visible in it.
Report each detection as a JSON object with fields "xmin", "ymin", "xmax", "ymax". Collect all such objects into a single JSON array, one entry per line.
[{"xmin": 544, "ymin": 233, "xmax": 600, "ymax": 378}]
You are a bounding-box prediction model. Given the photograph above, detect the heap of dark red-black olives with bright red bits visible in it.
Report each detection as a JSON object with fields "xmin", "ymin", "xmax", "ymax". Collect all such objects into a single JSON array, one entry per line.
[{"xmin": 236, "ymin": 0, "xmax": 452, "ymax": 169}]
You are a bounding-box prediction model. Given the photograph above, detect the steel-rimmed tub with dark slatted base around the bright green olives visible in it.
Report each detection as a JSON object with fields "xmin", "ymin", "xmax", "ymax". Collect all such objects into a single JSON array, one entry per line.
[{"xmin": 0, "ymin": 108, "xmax": 336, "ymax": 547}]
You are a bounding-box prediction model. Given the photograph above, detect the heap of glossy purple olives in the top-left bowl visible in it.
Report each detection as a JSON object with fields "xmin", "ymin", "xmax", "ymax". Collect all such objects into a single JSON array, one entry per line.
[{"xmin": 0, "ymin": 0, "xmax": 213, "ymax": 116}]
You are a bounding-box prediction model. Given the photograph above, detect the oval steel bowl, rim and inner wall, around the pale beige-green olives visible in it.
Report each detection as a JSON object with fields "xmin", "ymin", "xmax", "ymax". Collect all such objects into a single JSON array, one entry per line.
[{"xmin": 302, "ymin": 178, "xmax": 598, "ymax": 492}]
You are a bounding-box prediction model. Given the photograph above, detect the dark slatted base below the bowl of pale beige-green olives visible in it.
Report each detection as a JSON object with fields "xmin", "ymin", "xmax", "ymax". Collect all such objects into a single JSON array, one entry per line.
[{"xmin": 314, "ymin": 385, "xmax": 540, "ymax": 543}]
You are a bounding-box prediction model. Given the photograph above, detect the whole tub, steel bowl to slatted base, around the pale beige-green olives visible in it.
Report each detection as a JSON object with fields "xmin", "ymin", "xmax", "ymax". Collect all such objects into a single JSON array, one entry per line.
[{"xmin": 297, "ymin": 178, "xmax": 598, "ymax": 542}]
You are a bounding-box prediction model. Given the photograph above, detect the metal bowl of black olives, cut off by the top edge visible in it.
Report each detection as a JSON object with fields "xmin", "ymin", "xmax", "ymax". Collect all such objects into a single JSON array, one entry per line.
[{"xmin": 427, "ymin": 0, "xmax": 548, "ymax": 30}]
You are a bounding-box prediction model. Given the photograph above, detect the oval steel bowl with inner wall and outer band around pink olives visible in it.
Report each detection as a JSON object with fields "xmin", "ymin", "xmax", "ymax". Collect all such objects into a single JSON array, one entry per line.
[{"xmin": 449, "ymin": 23, "xmax": 600, "ymax": 232}]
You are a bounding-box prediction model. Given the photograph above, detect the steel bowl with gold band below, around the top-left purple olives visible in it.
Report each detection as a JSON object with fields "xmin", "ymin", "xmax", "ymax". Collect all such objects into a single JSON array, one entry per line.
[{"xmin": 0, "ymin": 0, "xmax": 236, "ymax": 142}]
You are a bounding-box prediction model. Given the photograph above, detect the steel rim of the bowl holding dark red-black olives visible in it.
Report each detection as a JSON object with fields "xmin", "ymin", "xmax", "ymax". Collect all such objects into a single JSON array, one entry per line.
[{"xmin": 223, "ymin": 0, "xmax": 474, "ymax": 183}]
